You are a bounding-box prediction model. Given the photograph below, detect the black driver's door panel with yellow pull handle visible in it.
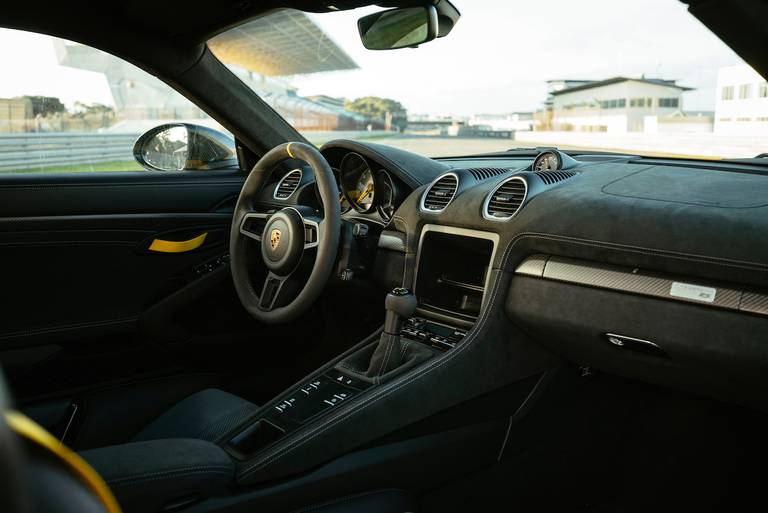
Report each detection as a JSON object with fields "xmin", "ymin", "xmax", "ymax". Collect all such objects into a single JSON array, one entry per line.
[{"xmin": 0, "ymin": 171, "xmax": 244, "ymax": 398}]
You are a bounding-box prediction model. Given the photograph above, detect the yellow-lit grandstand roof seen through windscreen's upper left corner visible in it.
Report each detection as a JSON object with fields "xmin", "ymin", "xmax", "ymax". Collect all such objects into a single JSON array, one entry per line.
[{"xmin": 208, "ymin": 9, "xmax": 358, "ymax": 76}]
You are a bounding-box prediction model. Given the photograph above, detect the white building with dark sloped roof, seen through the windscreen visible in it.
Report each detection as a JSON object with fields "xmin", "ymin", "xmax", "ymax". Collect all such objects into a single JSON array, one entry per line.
[{"xmin": 549, "ymin": 77, "xmax": 691, "ymax": 134}]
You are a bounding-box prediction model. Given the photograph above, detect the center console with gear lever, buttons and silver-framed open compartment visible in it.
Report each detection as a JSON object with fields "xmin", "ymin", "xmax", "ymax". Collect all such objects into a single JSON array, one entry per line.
[{"xmin": 224, "ymin": 225, "xmax": 498, "ymax": 461}]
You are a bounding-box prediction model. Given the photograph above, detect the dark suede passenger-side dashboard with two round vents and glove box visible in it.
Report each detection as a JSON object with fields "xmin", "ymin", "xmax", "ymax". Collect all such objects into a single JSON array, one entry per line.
[{"xmin": 364, "ymin": 141, "xmax": 768, "ymax": 409}]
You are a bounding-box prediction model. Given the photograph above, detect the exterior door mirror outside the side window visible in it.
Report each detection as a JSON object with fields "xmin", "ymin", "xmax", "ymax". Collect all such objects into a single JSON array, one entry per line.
[{"xmin": 133, "ymin": 123, "xmax": 238, "ymax": 171}]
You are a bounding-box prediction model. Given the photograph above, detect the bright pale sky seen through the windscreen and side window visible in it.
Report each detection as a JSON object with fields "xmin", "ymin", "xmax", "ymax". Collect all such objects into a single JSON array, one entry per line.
[{"xmin": 0, "ymin": 0, "xmax": 742, "ymax": 116}]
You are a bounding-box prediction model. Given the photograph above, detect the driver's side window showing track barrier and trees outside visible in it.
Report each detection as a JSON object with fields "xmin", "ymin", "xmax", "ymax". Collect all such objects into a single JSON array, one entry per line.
[{"xmin": 0, "ymin": 29, "xmax": 236, "ymax": 174}]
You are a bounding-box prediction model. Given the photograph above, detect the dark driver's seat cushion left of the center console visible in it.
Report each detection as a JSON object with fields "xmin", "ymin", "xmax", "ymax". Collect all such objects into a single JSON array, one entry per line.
[{"xmin": 133, "ymin": 388, "xmax": 258, "ymax": 442}]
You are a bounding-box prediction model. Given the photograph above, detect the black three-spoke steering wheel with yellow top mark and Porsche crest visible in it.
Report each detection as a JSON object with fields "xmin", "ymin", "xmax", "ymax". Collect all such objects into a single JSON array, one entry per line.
[{"xmin": 229, "ymin": 142, "xmax": 341, "ymax": 324}]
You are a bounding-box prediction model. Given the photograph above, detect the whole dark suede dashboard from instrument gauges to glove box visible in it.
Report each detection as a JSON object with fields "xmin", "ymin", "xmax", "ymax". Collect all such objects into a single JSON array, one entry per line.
[{"xmin": 304, "ymin": 141, "xmax": 768, "ymax": 409}]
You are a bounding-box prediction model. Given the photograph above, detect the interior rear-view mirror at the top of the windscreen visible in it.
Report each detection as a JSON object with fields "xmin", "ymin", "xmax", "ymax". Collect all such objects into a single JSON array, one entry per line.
[{"xmin": 357, "ymin": 0, "xmax": 461, "ymax": 50}]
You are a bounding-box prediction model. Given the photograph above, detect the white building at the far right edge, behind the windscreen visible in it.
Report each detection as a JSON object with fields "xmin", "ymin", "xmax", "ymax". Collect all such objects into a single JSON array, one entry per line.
[{"xmin": 715, "ymin": 64, "xmax": 768, "ymax": 135}]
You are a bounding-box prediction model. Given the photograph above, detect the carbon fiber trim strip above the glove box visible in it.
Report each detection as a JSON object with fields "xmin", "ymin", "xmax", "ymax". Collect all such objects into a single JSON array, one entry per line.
[{"xmin": 515, "ymin": 255, "xmax": 768, "ymax": 315}]
